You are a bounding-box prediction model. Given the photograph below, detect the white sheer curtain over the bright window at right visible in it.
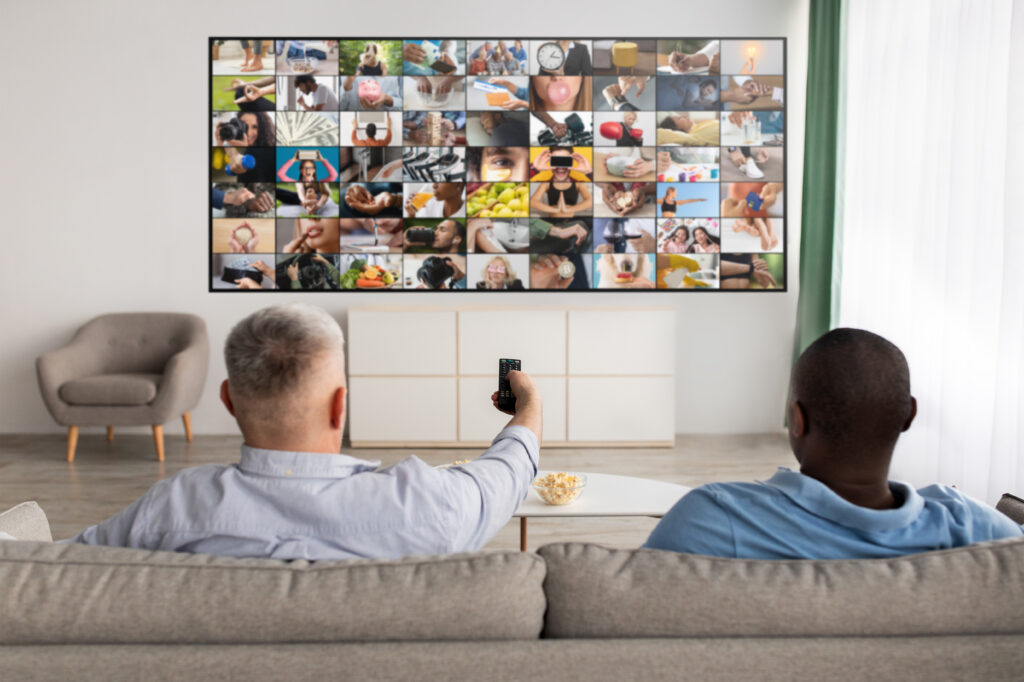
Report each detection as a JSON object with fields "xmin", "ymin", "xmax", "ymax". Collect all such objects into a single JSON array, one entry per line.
[{"xmin": 835, "ymin": 0, "xmax": 1024, "ymax": 504}]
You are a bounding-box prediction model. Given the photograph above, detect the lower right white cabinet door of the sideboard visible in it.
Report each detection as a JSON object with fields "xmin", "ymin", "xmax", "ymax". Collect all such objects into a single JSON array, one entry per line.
[{"xmin": 568, "ymin": 377, "xmax": 676, "ymax": 442}]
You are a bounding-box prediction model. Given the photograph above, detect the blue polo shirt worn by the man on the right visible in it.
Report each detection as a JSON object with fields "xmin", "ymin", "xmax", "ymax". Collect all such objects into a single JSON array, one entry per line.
[{"xmin": 643, "ymin": 467, "xmax": 1024, "ymax": 559}]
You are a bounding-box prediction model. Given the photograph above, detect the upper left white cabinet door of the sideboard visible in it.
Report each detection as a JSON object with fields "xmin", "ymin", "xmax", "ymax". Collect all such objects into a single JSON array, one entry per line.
[{"xmin": 348, "ymin": 310, "xmax": 456, "ymax": 376}]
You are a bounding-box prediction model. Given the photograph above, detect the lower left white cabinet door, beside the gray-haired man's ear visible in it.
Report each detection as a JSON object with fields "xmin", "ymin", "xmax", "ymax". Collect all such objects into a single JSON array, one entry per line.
[{"xmin": 348, "ymin": 377, "xmax": 457, "ymax": 443}]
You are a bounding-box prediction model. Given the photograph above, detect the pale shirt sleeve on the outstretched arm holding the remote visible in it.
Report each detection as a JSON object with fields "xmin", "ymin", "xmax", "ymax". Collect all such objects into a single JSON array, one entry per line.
[{"xmin": 441, "ymin": 425, "xmax": 541, "ymax": 552}]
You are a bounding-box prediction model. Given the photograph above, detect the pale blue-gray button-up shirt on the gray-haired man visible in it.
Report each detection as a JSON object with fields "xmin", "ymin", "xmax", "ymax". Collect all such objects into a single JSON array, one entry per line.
[{"xmin": 67, "ymin": 426, "xmax": 540, "ymax": 559}]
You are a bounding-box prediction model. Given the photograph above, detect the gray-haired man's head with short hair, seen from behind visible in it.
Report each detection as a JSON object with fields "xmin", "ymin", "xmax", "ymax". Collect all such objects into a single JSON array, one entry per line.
[{"xmin": 220, "ymin": 303, "xmax": 345, "ymax": 453}]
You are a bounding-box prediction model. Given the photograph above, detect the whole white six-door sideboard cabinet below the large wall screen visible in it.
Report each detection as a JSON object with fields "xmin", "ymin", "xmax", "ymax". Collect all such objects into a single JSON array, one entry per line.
[{"xmin": 347, "ymin": 306, "xmax": 676, "ymax": 447}]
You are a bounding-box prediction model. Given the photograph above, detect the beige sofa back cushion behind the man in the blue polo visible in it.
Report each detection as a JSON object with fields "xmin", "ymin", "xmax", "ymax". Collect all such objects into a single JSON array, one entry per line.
[{"xmin": 538, "ymin": 539, "xmax": 1024, "ymax": 638}]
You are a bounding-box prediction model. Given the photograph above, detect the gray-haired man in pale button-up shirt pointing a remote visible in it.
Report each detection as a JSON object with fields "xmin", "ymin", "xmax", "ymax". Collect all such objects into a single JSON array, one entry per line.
[{"xmin": 71, "ymin": 303, "xmax": 541, "ymax": 559}]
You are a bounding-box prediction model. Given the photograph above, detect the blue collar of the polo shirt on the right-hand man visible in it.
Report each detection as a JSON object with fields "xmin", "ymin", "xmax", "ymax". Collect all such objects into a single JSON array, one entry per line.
[{"xmin": 758, "ymin": 467, "xmax": 925, "ymax": 530}]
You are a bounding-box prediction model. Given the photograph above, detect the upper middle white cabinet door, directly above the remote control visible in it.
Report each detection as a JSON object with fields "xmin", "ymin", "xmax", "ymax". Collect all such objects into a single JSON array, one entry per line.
[{"xmin": 459, "ymin": 310, "xmax": 565, "ymax": 374}]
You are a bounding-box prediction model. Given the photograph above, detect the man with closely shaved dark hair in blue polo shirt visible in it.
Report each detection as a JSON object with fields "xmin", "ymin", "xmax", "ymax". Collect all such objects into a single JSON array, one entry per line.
[{"xmin": 643, "ymin": 329, "xmax": 1022, "ymax": 559}]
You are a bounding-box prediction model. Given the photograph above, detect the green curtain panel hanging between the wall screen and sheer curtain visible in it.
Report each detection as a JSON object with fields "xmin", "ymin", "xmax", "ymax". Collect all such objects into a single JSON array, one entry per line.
[{"xmin": 794, "ymin": 0, "xmax": 843, "ymax": 359}]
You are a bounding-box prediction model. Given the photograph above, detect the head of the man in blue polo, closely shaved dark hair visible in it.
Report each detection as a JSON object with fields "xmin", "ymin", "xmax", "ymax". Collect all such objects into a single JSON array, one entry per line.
[{"xmin": 788, "ymin": 328, "xmax": 918, "ymax": 471}]
